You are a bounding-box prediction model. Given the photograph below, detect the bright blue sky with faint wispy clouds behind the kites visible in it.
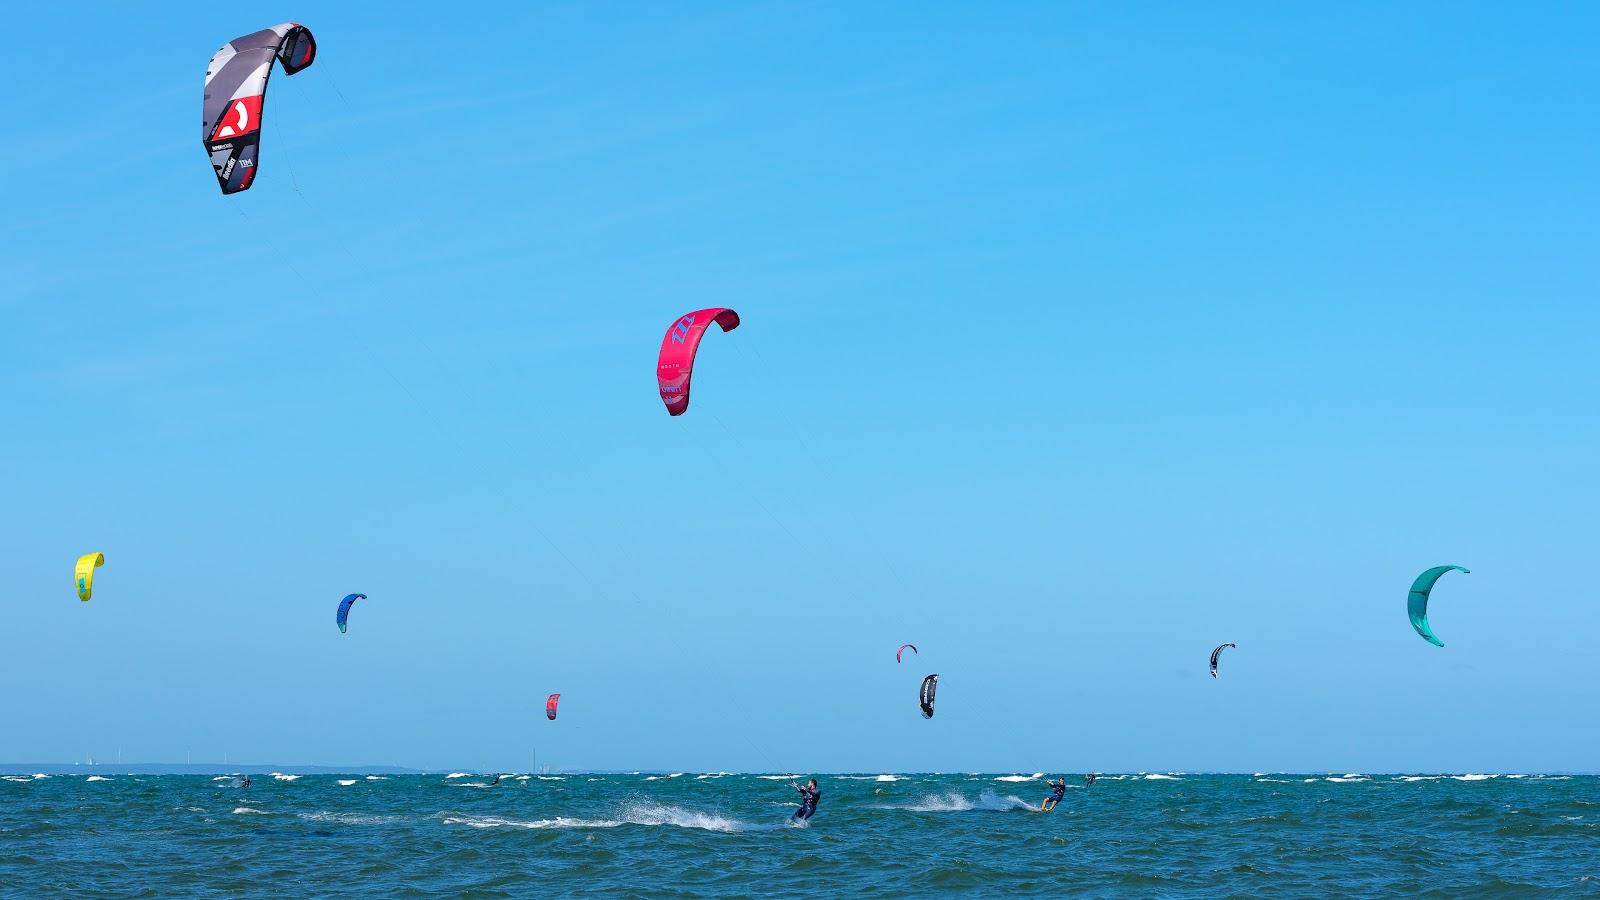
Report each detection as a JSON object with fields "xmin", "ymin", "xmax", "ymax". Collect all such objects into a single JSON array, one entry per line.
[{"xmin": 0, "ymin": 2, "xmax": 1600, "ymax": 772}]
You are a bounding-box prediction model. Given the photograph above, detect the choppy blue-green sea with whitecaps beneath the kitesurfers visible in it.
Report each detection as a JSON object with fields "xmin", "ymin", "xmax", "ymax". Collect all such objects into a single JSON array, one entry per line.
[{"xmin": 0, "ymin": 767, "xmax": 1600, "ymax": 897}]
